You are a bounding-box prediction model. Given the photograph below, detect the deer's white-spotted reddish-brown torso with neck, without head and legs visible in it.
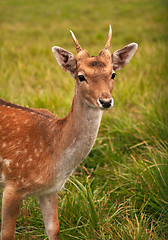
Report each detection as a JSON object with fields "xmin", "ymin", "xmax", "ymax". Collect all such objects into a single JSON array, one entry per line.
[{"xmin": 0, "ymin": 95, "xmax": 102, "ymax": 197}]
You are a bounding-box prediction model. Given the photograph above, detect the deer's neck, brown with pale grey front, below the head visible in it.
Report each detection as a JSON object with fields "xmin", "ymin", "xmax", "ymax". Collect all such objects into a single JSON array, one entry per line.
[{"xmin": 56, "ymin": 86, "xmax": 102, "ymax": 174}]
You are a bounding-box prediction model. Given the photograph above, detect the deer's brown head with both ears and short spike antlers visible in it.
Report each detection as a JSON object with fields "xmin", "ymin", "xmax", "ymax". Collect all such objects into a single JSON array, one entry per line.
[{"xmin": 52, "ymin": 26, "xmax": 138, "ymax": 109}]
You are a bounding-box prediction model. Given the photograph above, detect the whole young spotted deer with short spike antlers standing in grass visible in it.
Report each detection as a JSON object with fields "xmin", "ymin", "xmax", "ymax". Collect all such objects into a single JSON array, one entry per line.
[{"xmin": 0, "ymin": 25, "xmax": 138, "ymax": 240}]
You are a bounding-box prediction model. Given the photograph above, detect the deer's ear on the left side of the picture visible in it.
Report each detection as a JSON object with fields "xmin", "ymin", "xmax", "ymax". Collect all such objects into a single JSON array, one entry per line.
[{"xmin": 52, "ymin": 46, "xmax": 77, "ymax": 77}]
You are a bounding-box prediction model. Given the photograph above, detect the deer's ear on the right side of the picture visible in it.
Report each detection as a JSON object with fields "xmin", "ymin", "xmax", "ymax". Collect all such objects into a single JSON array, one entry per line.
[{"xmin": 112, "ymin": 43, "xmax": 138, "ymax": 71}]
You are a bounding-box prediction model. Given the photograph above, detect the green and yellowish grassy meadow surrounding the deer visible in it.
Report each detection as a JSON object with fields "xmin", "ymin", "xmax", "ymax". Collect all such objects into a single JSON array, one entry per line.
[{"xmin": 0, "ymin": 0, "xmax": 168, "ymax": 240}]
